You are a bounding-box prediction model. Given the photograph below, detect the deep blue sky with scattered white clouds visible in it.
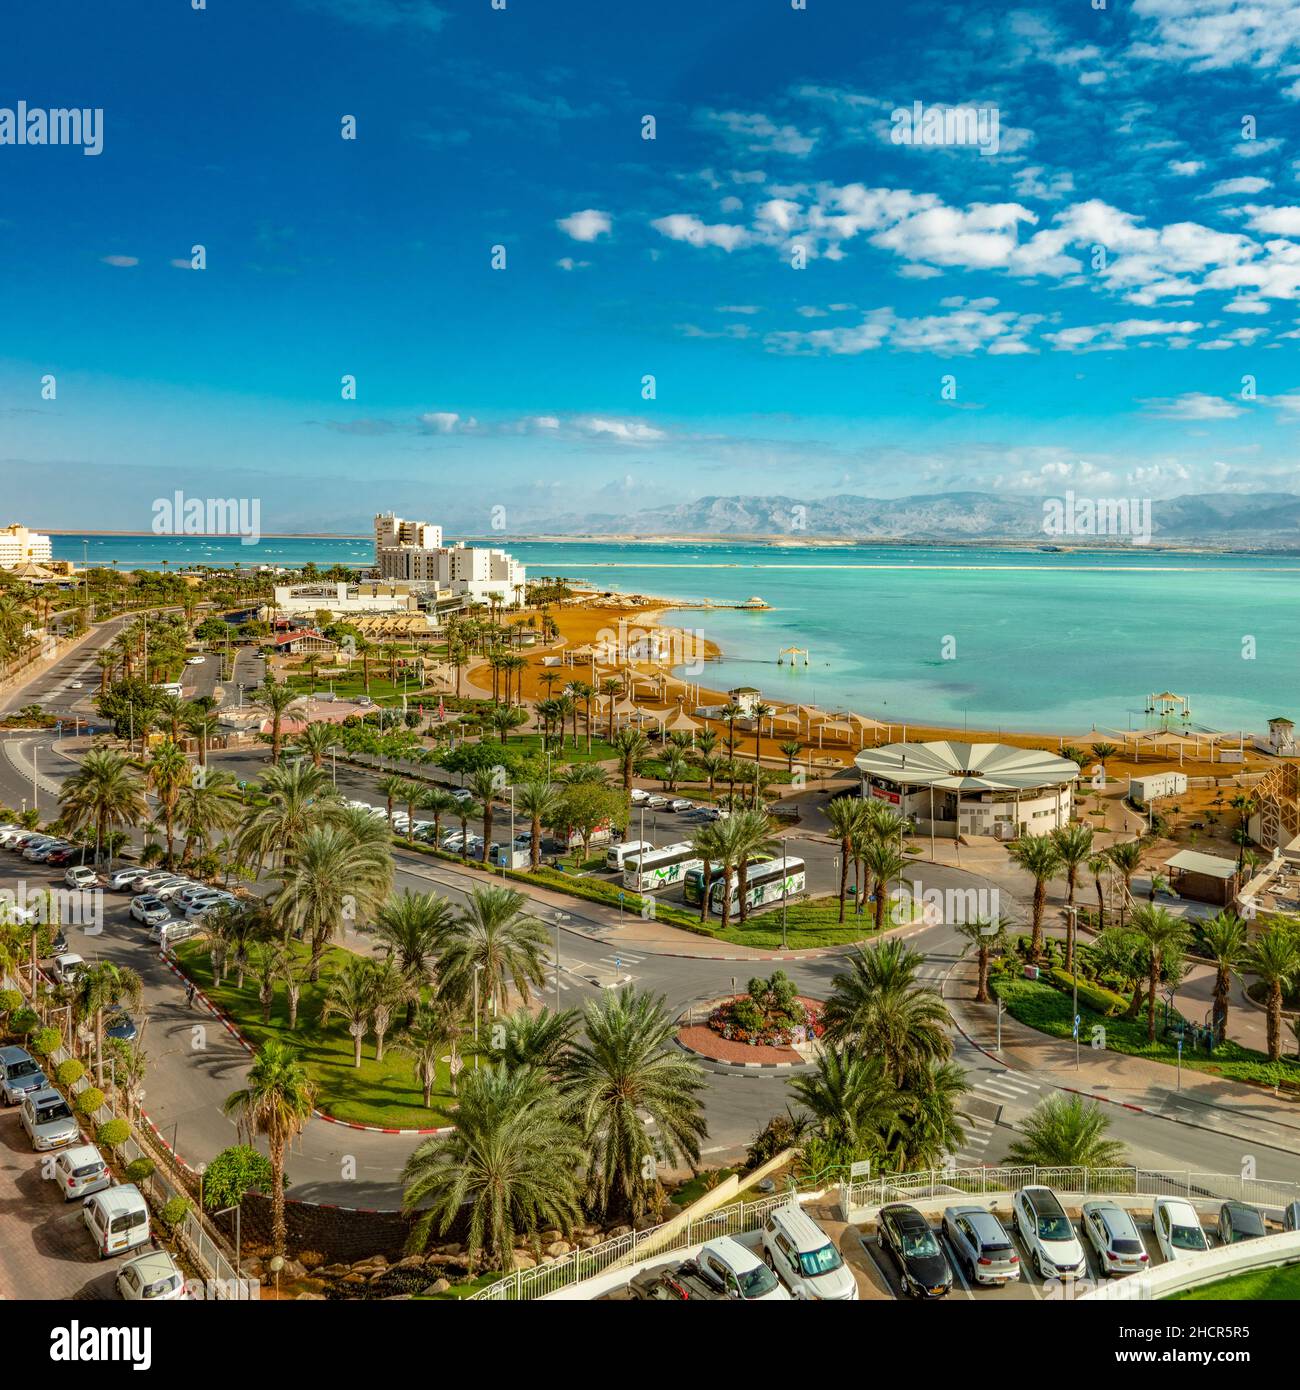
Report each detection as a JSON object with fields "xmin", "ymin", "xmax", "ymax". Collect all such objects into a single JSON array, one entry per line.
[{"xmin": 0, "ymin": 0, "xmax": 1300, "ymax": 534}]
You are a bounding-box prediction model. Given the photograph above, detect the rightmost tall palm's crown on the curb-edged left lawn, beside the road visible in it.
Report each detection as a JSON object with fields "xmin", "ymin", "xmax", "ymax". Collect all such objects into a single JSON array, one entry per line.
[{"xmin": 438, "ymin": 887, "xmax": 548, "ymax": 1016}]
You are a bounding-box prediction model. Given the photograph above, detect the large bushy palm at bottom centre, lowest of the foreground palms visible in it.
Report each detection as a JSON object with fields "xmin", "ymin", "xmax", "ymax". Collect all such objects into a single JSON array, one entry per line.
[{"xmin": 402, "ymin": 1066, "xmax": 584, "ymax": 1270}]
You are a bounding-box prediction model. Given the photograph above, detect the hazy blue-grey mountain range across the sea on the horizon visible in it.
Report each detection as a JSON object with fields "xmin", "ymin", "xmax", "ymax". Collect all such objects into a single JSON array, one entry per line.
[{"xmin": 530, "ymin": 492, "xmax": 1300, "ymax": 549}]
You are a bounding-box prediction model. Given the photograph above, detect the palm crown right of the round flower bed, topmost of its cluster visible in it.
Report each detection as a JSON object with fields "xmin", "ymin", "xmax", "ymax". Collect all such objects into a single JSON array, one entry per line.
[{"xmin": 822, "ymin": 937, "xmax": 952, "ymax": 1084}]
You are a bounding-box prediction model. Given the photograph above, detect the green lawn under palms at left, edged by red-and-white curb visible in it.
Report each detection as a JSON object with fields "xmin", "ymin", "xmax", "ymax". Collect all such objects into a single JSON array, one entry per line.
[{"xmin": 167, "ymin": 941, "xmax": 467, "ymax": 1129}]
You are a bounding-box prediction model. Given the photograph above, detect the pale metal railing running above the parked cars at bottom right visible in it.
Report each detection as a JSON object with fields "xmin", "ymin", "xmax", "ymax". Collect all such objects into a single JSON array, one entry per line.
[{"xmin": 470, "ymin": 1166, "xmax": 1300, "ymax": 1301}]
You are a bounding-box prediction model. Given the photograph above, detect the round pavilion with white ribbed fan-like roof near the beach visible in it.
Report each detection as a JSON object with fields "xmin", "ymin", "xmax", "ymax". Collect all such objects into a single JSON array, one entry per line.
[{"xmin": 855, "ymin": 739, "xmax": 1079, "ymax": 840}]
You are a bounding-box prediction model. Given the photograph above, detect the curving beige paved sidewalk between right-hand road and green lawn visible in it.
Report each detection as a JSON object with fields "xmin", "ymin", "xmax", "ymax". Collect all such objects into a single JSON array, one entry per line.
[{"xmin": 943, "ymin": 959, "xmax": 1300, "ymax": 1145}]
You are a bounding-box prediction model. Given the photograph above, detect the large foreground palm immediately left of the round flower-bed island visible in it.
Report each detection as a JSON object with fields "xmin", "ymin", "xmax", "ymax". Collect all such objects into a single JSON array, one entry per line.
[{"xmin": 563, "ymin": 987, "xmax": 708, "ymax": 1218}]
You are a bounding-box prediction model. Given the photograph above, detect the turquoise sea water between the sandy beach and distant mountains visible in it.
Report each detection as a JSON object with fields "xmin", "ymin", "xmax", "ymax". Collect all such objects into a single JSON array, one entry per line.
[{"xmin": 54, "ymin": 537, "xmax": 1300, "ymax": 733}]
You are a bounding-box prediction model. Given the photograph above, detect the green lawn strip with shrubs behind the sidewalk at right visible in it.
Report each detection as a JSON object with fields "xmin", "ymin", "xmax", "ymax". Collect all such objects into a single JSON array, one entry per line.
[{"xmin": 990, "ymin": 979, "xmax": 1300, "ymax": 1086}]
